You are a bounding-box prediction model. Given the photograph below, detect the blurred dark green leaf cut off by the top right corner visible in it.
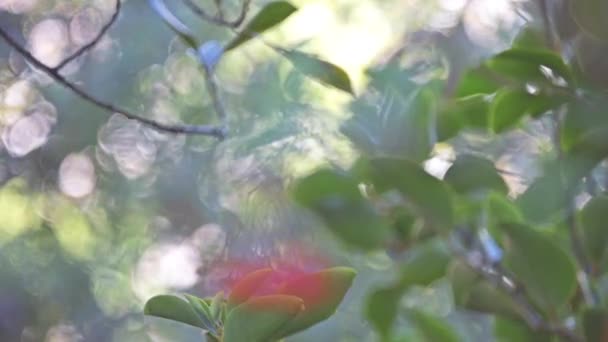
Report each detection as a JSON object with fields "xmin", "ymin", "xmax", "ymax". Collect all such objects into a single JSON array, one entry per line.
[{"xmin": 570, "ymin": 0, "xmax": 608, "ymax": 41}]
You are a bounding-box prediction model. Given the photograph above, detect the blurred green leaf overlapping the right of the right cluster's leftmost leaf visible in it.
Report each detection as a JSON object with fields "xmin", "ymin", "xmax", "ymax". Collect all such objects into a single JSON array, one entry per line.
[{"xmin": 355, "ymin": 158, "xmax": 454, "ymax": 229}]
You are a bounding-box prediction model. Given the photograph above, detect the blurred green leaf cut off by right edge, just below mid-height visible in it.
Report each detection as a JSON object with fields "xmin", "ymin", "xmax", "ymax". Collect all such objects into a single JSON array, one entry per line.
[{"xmin": 579, "ymin": 195, "xmax": 608, "ymax": 265}]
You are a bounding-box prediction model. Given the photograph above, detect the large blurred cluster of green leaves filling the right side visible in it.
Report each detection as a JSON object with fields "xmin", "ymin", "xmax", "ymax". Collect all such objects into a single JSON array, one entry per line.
[{"xmin": 294, "ymin": 10, "xmax": 608, "ymax": 342}]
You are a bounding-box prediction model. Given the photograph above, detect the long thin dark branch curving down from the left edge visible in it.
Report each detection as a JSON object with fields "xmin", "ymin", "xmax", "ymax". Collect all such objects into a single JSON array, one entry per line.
[{"xmin": 0, "ymin": 28, "xmax": 226, "ymax": 139}]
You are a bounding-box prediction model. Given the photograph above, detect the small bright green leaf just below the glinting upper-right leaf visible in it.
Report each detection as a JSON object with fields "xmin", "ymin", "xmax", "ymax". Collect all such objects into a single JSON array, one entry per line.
[{"xmin": 490, "ymin": 88, "xmax": 566, "ymax": 133}]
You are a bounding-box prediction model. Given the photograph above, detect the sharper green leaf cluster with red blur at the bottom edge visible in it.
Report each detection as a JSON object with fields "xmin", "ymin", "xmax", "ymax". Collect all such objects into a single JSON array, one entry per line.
[{"xmin": 144, "ymin": 267, "xmax": 356, "ymax": 342}]
